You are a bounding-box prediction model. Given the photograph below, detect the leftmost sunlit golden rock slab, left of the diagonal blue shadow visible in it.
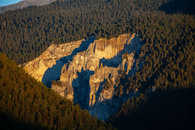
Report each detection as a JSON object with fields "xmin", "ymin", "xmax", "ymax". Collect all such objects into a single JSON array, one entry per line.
[{"xmin": 24, "ymin": 40, "xmax": 82, "ymax": 81}]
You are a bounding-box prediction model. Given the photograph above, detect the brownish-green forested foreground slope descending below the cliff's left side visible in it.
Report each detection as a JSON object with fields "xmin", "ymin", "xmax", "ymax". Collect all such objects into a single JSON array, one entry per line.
[{"xmin": 0, "ymin": 54, "xmax": 110, "ymax": 130}]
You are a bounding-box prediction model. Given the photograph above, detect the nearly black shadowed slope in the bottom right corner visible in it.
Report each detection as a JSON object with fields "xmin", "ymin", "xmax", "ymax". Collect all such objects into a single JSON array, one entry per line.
[{"xmin": 109, "ymin": 89, "xmax": 195, "ymax": 130}]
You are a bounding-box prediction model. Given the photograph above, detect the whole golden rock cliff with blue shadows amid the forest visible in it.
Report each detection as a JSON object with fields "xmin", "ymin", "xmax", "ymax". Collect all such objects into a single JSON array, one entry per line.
[{"xmin": 24, "ymin": 34, "xmax": 140, "ymax": 120}]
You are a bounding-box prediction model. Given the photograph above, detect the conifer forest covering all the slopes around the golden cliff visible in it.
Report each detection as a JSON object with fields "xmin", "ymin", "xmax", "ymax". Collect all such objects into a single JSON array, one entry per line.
[{"xmin": 0, "ymin": 0, "xmax": 195, "ymax": 130}]
